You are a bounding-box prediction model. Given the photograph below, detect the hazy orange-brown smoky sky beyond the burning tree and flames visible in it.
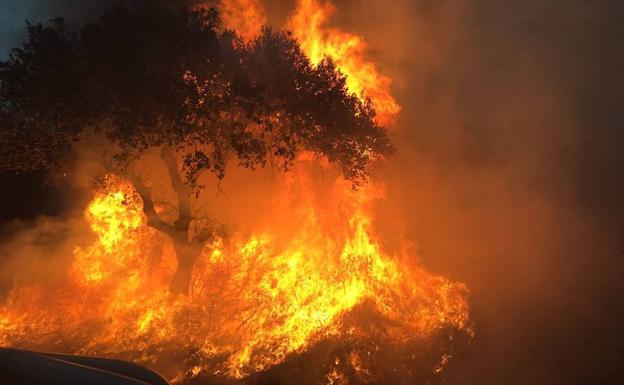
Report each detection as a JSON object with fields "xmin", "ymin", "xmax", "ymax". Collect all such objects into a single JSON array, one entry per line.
[{"xmin": 0, "ymin": 0, "xmax": 624, "ymax": 385}]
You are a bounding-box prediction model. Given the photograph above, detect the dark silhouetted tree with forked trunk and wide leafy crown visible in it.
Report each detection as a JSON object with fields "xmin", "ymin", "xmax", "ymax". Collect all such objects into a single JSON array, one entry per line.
[{"xmin": 0, "ymin": 1, "xmax": 391, "ymax": 292}]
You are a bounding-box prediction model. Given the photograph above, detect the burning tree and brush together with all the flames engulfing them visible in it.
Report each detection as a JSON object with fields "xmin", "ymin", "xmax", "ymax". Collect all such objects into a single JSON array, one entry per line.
[{"xmin": 0, "ymin": 0, "xmax": 472, "ymax": 384}]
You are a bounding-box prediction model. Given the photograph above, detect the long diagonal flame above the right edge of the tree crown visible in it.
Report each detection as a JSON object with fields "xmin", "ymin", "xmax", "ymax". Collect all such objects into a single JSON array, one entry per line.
[{"xmin": 286, "ymin": 0, "xmax": 401, "ymax": 126}]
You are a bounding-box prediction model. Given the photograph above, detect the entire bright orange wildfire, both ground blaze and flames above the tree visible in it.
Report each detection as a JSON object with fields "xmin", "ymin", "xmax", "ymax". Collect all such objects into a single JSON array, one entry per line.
[{"xmin": 0, "ymin": 0, "xmax": 471, "ymax": 384}]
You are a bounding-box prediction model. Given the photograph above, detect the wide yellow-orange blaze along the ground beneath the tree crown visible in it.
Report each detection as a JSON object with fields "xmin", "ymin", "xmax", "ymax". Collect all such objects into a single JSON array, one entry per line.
[{"xmin": 0, "ymin": 173, "xmax": 469, "ymax": 381}]
